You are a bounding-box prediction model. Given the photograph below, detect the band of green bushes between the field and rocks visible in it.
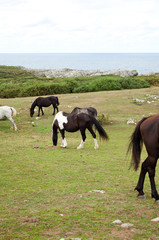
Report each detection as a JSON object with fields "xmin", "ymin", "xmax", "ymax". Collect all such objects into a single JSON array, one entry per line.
[{"xmin": 0, "ymin": 66, "xmax": 159, "ymax": 98}]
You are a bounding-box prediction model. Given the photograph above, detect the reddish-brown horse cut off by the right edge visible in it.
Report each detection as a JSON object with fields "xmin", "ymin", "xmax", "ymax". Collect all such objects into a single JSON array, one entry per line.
[{"xmin": 128, "ymin": 114, "xmax": 159, "ymax": 203}]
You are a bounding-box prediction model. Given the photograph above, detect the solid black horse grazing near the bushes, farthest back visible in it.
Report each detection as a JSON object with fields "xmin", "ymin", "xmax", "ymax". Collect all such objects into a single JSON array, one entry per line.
[{"xmin": 30, "ymin": 96, "xmax": 60, "ymax": 117}]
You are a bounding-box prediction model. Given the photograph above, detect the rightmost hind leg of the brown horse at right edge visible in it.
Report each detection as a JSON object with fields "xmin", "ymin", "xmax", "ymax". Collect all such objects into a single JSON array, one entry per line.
[{"xmin": 148, "ymin": 157, "xmax": 159, "ymax": 202}]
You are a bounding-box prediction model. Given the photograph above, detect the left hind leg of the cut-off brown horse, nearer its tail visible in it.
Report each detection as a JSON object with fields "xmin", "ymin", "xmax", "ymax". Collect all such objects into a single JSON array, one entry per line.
[{"xmin": 135, "ymin": 158, "xmax": 148, "ymax": 198}]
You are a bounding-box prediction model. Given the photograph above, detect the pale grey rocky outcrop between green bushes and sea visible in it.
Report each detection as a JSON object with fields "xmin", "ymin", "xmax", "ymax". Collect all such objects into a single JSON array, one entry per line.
[{"xmin": 29, "ymin": 68, "xmax": 138, "ymax": 78}]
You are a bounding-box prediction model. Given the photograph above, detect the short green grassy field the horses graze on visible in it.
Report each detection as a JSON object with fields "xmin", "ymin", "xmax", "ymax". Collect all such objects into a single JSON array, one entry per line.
[{"xmin": 0, "ymin": 87, "xmax": 159, "ymax": 240}]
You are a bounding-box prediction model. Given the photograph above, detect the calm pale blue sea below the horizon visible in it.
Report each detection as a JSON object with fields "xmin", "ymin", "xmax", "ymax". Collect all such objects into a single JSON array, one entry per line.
[{"xmin": 0, "ymin": 53, "xmax": 159, "ymax": 75}]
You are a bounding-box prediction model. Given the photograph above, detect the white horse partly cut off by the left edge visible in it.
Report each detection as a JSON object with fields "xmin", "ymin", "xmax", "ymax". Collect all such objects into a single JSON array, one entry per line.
[{"xmin": 0, "ymin": 106, "xmax": 17, "ymax": 131}]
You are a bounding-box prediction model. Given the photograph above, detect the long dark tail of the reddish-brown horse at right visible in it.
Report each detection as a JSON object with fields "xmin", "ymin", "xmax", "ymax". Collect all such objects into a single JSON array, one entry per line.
[{"xmin": 127, "ymin": 117, "xmax": 148, "ymax": 171}]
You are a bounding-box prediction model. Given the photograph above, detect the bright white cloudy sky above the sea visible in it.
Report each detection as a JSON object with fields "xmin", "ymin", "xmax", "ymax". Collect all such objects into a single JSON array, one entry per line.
[{"xmin": 0, "ymin": 0, "xmax": 159, "ymax": 53}]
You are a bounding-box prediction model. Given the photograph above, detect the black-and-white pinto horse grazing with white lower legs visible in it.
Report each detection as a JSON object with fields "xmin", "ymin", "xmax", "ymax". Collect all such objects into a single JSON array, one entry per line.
[{"xmin": 52, "ymin": 111, "xmax": 108, "ymax": 149}]
